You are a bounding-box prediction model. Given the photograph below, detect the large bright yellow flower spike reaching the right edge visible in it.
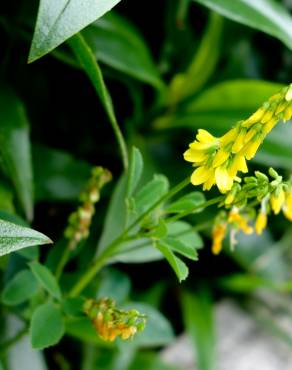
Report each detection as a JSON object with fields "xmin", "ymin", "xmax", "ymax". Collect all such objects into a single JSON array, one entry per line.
[{"xmin": 184, "ymin": 84, "xmax": 292, "ymax": 193}]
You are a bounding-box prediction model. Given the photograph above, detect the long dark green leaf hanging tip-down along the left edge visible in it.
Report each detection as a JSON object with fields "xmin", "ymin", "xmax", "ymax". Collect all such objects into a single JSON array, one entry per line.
[{"xmin": 0, "ymin": 87, "xmax": 33, "ymax": 220}]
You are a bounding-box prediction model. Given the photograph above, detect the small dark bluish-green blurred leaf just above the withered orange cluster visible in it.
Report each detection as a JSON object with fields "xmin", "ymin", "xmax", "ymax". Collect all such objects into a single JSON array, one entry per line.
[{"xmin": 97, "ymin": 268, "xmax": 131, "ymax": 303}]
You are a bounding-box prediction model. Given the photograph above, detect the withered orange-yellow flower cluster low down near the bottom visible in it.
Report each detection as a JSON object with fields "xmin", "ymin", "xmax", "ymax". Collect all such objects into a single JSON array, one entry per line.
[{"xmin": 83, "ymin": 298, "xmax": 146, "ymax": 342}]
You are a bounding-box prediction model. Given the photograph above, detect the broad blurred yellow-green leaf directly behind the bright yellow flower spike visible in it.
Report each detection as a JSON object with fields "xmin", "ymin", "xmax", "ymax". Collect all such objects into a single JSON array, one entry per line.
[{"xmin": 155, "ymin": 80, "xmax": 283, "ymax": 134}]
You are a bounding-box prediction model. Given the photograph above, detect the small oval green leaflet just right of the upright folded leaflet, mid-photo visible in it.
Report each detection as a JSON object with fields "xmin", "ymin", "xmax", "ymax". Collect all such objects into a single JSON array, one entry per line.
[{"xmin": 134, "ymin": 175, "xmax": 169, "ymax": 215}]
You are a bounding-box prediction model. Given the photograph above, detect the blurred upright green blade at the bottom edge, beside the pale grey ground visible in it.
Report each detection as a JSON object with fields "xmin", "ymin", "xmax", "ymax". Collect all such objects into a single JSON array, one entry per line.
[{"xmin": 182, "ymin": 292, "xmax": 216, "ymax": 370}]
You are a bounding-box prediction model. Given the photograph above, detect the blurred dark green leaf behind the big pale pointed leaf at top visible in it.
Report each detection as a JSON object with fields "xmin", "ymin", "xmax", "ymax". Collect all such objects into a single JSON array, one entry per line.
[{"xmin": 82, "ymin": 12, "xmax": 163, "ymax": 88}]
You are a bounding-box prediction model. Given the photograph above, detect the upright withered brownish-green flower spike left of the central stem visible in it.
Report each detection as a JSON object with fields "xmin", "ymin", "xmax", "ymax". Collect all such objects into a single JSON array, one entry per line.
[{"xmin": 65, "ymin": 167, "xmax": 112, "ymax": 250}]
